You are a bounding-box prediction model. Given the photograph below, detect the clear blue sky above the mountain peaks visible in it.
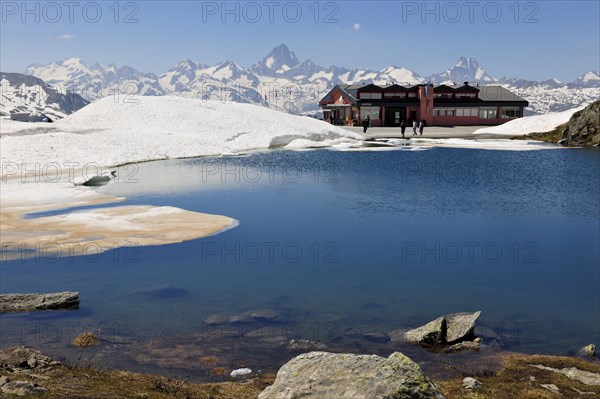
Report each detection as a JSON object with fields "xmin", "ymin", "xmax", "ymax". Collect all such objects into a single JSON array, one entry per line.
[{"xmin": 0, "ymin": 0, "xmax": 600, "ymax": 81}]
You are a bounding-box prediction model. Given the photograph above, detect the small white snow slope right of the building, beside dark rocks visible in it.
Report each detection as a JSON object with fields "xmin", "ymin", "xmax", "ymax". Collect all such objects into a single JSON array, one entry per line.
[{"xmin": 473, "ymin": 106, "xmax": 585, "ymax": 136}]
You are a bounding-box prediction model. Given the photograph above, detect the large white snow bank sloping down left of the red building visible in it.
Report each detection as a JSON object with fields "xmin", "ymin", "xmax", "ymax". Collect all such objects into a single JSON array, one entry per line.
[{"xmin": 0, "ymin": 96, "xmax": 361, "ymax": 176}]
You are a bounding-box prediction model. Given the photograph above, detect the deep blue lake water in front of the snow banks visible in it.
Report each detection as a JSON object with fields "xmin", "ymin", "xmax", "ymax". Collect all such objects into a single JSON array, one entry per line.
[{"xmin": 0, "ymin": 148, "xmax": 600, "ymax": 378}]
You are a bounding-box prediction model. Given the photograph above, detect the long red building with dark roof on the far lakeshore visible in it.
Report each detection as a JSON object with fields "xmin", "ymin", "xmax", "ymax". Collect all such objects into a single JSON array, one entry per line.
[{"xmin": 319, "ymin": 82, "xmax": 529, "ymax": 126}]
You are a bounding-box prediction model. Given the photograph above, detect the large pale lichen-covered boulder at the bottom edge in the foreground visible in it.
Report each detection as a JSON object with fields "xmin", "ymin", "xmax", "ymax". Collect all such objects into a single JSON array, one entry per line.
[{"xmin": 258, "ymin": 352, "xmax": 444, "ymax": 399}]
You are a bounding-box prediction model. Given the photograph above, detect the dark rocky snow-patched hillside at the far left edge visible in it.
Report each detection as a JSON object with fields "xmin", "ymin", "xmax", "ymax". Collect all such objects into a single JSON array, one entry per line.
[{"xmin": 0, "ymin": 72, "xmax": 88, "ymax": 120}]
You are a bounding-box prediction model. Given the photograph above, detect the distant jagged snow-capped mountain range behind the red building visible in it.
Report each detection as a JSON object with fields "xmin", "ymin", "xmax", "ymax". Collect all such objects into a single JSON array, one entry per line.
[{"xmin": 5, "ymin": 44, "xmax": 600, "ymax": 119}]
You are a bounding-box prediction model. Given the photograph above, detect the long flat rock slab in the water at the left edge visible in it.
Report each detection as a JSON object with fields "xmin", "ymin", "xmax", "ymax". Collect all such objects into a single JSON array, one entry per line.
[{"xmin": 0, "ymin": 292, "xmax": 79, "ymax": 313}]
